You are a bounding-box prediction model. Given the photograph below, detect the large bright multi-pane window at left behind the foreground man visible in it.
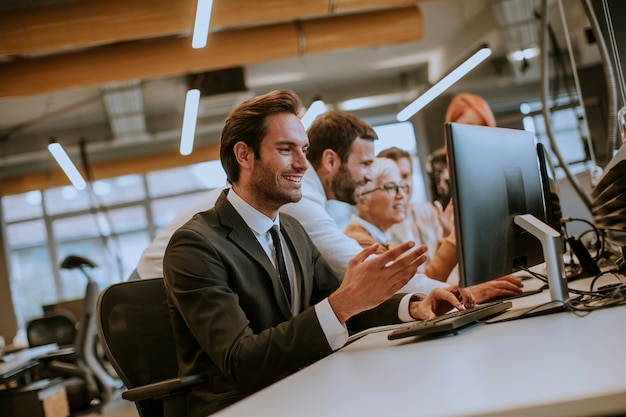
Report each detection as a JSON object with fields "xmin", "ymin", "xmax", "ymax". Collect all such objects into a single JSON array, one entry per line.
[{"xmin": 2, "ymin": 161, "xmax": 226, "ymax": 328}]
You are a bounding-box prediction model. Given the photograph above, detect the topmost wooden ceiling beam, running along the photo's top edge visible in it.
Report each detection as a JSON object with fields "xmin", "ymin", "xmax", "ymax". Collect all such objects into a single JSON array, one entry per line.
[{"xmin": 0, "ymin": 0, "xmax": 423, "ymax": 56}]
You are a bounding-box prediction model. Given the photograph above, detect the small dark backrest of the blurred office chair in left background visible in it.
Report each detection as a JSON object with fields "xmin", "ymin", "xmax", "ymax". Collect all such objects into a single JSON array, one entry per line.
[{"xmin": 26, "ymin": 311, "xmax": 77, "ymax": 347}]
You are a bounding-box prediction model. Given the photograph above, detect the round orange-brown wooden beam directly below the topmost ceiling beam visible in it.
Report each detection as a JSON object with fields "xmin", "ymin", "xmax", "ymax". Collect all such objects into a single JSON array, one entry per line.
[{"xmin": 0, "ymin": 6, "xmax": 423, "ymax": 98}]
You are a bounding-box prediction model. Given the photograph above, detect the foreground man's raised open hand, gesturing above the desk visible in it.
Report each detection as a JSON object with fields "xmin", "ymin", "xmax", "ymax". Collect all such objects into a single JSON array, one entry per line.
[{"xmin": 328, "ymin": 242, "xmax": 427, "ymax": 323}]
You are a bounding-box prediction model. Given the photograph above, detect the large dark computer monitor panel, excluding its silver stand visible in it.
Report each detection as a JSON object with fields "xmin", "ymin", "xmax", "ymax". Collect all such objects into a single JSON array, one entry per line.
[{"xmin": 446, "ymin": 123, "xmax": 544, "ymax": 286}]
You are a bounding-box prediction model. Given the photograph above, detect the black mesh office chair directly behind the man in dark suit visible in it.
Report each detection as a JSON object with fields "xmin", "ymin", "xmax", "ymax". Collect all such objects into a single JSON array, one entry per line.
[{"xmin": 96, "ymin": 278, "xmax": 207, "ymax": 417}]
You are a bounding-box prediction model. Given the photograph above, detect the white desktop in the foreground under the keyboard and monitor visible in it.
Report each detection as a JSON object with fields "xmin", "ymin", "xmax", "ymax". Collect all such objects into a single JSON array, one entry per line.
[{"xmin": 212, "ymin": 276, "xmax": 626, "ymax": 417}]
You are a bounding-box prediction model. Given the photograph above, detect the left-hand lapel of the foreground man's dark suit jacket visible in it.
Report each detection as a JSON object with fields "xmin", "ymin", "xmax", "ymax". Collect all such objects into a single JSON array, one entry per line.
[{"xmin": 215, "ymin": 190, "xmax": 293, "ymax": 319}]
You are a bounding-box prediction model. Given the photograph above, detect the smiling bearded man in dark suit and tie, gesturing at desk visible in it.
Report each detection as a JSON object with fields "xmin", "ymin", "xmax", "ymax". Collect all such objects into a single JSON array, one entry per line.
[{"xmin": 163, "ymin": 90, "xmax": 471, "ymax": 417}]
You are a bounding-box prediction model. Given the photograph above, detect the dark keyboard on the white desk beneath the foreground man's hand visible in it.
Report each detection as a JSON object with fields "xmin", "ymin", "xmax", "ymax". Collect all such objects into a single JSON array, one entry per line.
[{"xmin": 387, "ymin": 301, "xmax": 513, "ymax": 340}]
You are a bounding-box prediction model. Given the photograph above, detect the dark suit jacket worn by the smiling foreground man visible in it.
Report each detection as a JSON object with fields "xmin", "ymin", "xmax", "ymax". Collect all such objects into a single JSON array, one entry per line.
[{"xmin": 163, "ymin": 190, "xmax": 401, "ymax": 416}]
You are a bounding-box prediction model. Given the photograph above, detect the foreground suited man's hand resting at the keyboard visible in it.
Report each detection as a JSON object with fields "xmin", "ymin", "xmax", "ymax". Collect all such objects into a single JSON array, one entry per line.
[{"xmin": 409, "ymin": 285, "xmax": 474, "ymax": 320}]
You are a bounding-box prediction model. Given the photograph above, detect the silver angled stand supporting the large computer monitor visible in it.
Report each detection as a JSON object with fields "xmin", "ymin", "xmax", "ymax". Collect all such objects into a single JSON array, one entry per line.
[{"xmin": 486, "ymin": 214, "xmax": 569, "ymax": 323}]
